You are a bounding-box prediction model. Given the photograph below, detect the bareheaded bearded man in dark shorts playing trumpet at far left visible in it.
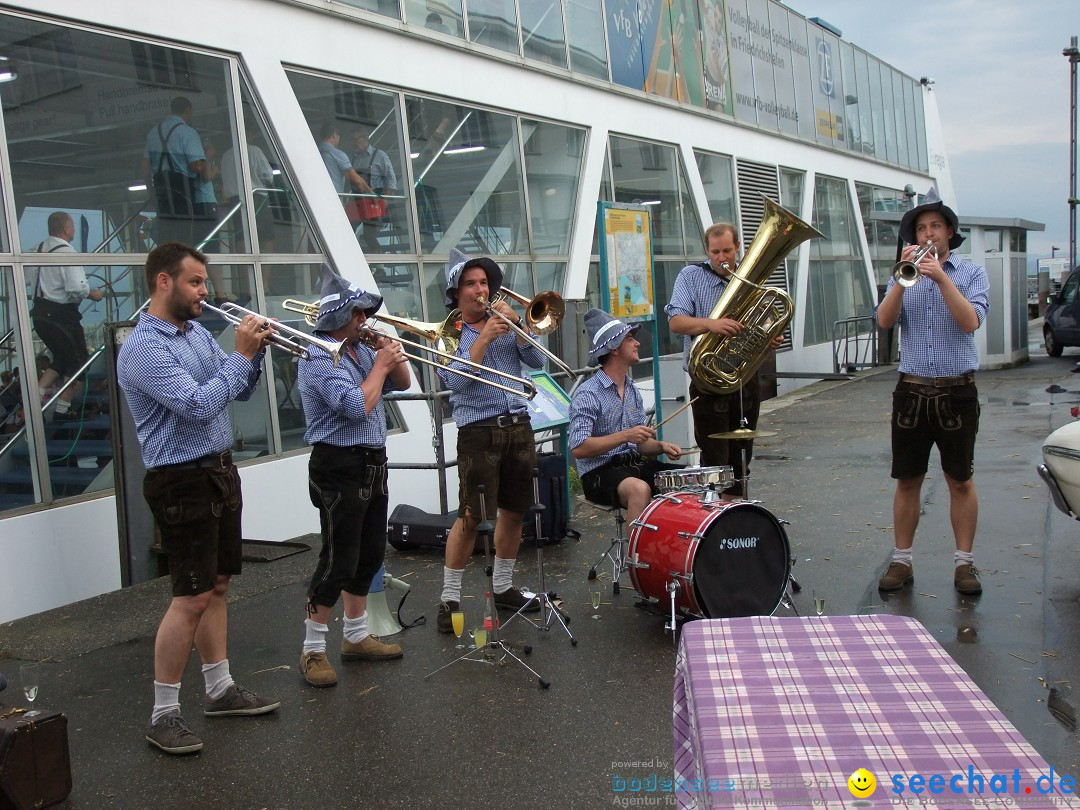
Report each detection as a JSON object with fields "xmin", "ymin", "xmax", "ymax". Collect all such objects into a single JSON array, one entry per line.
[{"xmin": 117, "ymin": 242, "xmax": 281, "ymax": 754}]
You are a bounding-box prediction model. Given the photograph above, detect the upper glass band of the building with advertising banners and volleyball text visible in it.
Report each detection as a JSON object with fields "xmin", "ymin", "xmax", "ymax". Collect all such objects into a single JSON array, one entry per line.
[{"xmin": 274, "ymin": 0, "xmax": 928, "ymax": 172}]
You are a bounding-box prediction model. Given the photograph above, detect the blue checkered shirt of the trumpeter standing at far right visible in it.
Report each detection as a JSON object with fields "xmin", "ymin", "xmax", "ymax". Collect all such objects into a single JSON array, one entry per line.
[{"xmin": 878, "ymin": 253, "xmax": 990, "ymax": 377}]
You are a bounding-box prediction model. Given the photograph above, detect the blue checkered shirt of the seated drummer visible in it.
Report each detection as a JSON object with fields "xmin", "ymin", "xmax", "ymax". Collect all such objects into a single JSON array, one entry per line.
[{"xmin": 568, "ymin": 368, "xmax": 645, "ymax": 477}]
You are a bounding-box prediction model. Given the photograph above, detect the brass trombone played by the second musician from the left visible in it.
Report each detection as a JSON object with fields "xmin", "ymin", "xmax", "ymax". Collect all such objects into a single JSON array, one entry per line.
[{"xmin": 282, "ymin": 298, "xmax": 537, "ymax": 400}]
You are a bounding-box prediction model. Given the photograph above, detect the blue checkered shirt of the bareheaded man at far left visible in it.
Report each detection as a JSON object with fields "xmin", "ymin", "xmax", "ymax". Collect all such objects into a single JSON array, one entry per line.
[{"xmin": 117, "ymin": 312, "xmax": 264, "ymax": 470}]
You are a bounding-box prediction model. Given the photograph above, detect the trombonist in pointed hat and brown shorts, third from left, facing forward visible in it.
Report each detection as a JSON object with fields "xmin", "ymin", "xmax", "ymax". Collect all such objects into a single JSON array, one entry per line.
[{"xmin": 437, "ymin": 249, "xmax": 543, "ymax": 633}]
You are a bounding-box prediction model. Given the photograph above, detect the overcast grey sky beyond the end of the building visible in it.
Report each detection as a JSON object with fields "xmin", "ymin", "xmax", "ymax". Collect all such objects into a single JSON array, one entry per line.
[{"xmin": 785, "ymin": 0, "xmax": 1080, "ymax": 257}]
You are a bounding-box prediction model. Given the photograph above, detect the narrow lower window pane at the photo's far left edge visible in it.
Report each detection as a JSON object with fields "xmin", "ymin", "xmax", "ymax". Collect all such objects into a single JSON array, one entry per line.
[{"xmin": 0, "ymin": 267, "xmax": 39, "ymax": 510}]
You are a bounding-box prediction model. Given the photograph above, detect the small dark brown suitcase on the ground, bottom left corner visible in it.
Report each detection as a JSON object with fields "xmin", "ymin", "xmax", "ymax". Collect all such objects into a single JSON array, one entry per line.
[{"xmin": 0, "ymin": 706, "xmax": 71, "ymax": 810}]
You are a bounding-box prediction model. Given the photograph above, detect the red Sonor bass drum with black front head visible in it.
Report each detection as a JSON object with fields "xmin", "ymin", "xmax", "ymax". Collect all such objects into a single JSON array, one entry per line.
[{"xmin": 629, "ymin": 492, "xmax": 792, "ymax": 619}]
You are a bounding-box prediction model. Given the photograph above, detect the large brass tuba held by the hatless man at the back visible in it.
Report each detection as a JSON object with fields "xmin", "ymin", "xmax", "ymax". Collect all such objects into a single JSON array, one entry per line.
[{"xmin": 687, "ymin": 197, "xmax": 824, "ymax": 394}]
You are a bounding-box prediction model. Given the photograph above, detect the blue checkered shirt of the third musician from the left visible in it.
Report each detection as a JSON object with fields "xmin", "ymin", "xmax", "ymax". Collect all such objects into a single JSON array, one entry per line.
[{"xmin": 438, "ymin": 323, "xmax": 543, "ymax": 428}]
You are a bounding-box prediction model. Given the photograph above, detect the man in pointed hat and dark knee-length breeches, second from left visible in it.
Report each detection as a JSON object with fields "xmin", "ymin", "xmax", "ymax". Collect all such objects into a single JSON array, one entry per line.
[{"xmin": 298, "ymin": 265, "xmax": 411, "ymax": 687}]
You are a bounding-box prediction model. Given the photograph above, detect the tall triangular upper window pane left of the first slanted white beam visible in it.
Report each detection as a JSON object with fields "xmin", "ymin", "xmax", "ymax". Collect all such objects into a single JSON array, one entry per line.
[{"xmin": 232, "ymin": 77, "xmax": 321, "ymax": 253}]
